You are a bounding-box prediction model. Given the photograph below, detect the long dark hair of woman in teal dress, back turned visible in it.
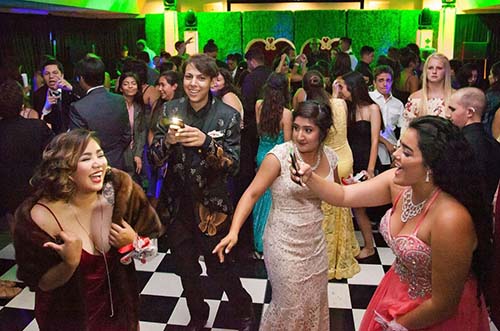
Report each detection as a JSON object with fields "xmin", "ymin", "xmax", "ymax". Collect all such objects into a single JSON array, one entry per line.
[{"xmin": 258, "ymin": 72, "xmax": 290, "ymax": 137}]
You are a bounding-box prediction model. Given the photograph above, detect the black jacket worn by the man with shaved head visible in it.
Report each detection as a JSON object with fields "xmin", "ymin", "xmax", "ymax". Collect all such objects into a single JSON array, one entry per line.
[{"xmin": 462, "ymin": 123, "xmax": 500, "ymax": 203}]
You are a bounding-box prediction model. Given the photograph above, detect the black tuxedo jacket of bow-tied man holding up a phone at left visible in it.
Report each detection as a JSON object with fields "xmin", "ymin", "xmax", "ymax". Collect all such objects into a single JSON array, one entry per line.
[{"xmin": 33, "ymin": 85, "xmax": 78, "ymax": 134}]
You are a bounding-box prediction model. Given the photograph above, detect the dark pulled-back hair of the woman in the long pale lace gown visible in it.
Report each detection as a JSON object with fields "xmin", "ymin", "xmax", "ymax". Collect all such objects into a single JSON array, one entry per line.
[{"xmin": 292, "ymin": 100, "xmax": 333, "ymax": 143}]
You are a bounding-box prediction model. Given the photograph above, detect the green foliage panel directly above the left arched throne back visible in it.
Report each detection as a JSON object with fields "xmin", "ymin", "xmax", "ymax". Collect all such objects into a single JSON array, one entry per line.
[{"xmin": 241, "ymin": 11, "xmax": 294, "ymax": 51}]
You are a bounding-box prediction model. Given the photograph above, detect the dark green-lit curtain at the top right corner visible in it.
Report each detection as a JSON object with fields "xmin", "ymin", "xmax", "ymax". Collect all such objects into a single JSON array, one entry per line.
[{"xmin": 455, "ymin": 14, "xmax": 500, "ymax": 67}]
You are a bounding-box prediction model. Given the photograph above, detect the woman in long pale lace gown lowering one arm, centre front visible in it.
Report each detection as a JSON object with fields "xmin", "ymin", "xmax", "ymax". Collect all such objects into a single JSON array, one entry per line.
[{"xmin": 214, "ymin": 101, "xmax": 338, "ymax": 331}]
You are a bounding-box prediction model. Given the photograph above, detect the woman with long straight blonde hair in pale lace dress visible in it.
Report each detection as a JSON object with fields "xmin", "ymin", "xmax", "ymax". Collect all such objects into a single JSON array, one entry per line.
[{"xmin": 401, "ymin": 53, "xmax": 453, "ymax": 133}]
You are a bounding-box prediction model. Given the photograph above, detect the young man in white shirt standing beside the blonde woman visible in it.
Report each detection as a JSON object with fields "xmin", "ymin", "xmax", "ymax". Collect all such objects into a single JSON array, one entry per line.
[{"xmin": 369, "ymin": 65, "xmax": 404, "ymax": 170}]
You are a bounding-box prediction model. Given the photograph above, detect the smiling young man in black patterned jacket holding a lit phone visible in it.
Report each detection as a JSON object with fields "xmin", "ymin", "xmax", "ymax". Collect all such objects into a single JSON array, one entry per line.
[{"xmin": 151, "ymin": 54, "xmax": 253, "ymax": 330}]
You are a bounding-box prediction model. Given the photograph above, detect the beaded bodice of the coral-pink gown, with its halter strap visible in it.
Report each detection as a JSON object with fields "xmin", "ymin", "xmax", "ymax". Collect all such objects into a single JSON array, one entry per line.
[{"xmin": 380, "ymin": 191, "xmax": 439, "ymax": 299}]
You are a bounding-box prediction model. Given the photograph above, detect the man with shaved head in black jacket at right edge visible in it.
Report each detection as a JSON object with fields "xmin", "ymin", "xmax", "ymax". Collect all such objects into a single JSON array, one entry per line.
[{"xmin": 447, "ymin": 87, "xmax": 500, "ymax": 203}]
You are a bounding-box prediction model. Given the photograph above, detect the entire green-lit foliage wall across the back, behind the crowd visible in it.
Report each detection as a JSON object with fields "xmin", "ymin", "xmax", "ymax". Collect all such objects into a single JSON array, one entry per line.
[{"xmin": 146, "ymin": 10, "xmax": 440, "ymax": 60}]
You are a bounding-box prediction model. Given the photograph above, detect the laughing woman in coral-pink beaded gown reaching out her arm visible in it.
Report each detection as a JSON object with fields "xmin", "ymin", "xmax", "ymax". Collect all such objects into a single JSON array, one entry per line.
[{"xmin": 292, "ymin": 116, "xmax": 491, "ymax": 331}]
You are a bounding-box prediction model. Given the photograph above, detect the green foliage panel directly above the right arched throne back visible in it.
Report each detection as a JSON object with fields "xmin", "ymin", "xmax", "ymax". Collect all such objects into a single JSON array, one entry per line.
[{"xmin": 294, "ymin": 10, "xmax": 346, "ymax": 51}]
